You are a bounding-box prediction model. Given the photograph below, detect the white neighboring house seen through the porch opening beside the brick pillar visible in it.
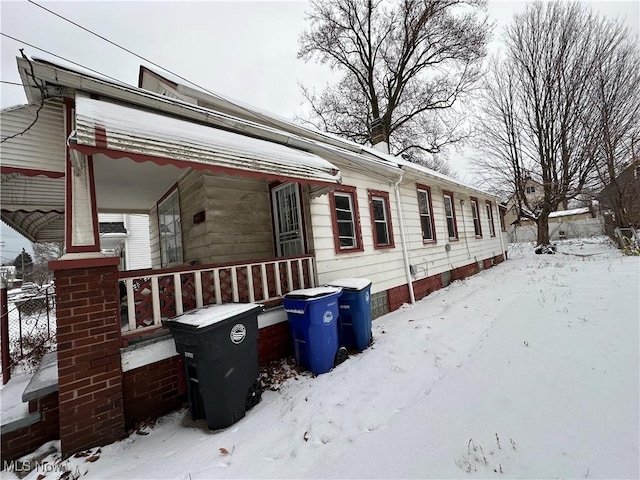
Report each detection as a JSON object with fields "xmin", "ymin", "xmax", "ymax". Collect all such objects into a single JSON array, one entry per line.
[{"xmin": 98, "ymin": 213, "xmax": 151, "ymax": 270}]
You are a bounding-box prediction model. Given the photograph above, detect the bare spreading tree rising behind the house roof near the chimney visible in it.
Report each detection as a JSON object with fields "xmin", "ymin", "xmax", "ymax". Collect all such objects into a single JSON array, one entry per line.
[{"xmin": 298, "ymin": 0, "xmax": 490, "ymax": 167}]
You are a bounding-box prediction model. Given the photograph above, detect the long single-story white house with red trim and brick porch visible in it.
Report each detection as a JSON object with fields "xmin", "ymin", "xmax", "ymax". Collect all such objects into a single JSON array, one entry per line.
[{"xmin": 0, "ymin": 58, "xmax": 505, "ymax": 458}]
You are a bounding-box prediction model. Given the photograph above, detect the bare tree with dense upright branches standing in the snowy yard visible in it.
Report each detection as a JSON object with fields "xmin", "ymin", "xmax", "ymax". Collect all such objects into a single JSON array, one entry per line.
[{"xmin": 476, "ymin": 1, "xmax": 636, "ymax": 245}]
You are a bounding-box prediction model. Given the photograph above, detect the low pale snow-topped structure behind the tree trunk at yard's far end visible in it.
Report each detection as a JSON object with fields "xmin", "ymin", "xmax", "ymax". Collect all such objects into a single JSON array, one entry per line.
[{"xmin": 507, "ymin": 207, "xmax": 604, "ymax": 243}]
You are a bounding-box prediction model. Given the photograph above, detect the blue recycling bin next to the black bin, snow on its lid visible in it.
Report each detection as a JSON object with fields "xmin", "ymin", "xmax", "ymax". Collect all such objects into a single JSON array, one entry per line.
[{"xmin": 283, "ymin": 287, "xmax": 346, "ymax": 375}]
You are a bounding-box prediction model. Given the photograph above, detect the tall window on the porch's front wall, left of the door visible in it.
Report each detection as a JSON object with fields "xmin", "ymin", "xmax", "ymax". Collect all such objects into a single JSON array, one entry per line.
[{"xmin": 158, "ymin": 185, "xmax": 183, "ymax": 267}]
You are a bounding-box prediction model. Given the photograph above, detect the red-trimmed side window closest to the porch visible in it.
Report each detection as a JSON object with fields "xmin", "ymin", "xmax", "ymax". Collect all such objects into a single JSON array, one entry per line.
[{"xmin": 329, "ymin": 186, "xmax": 363, "ymax": 252}]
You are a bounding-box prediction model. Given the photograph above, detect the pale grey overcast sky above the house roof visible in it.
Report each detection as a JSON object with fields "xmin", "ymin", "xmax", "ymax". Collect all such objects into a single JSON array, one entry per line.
[{"xmin": 0, "ymin": 0, "xmax": 640, "ymax": 262}]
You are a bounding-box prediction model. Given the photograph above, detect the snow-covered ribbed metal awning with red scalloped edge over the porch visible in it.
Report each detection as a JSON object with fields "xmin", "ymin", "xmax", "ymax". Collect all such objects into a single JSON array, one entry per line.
[{"xmin": 71, "ymin": 96, "xmax": 340, "ymax": 185}]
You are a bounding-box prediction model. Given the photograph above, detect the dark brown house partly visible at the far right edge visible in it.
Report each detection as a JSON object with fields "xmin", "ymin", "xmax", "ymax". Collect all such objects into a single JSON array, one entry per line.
[{"xmin": 598, "ymin": 160, "xmax": 640, "ymax": 228}]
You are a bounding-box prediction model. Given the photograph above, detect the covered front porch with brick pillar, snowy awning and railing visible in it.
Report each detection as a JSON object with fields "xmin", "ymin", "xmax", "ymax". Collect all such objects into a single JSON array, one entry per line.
[{"xmin": 0, "ymin": 82, "xmax": 340, "ymax": 454}]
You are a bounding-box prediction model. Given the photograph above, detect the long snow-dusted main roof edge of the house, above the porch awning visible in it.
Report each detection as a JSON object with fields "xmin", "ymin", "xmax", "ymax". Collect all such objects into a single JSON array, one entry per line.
[{"xmin": 17, "ymin": 58, "xmax": 493, "ymax": 196}]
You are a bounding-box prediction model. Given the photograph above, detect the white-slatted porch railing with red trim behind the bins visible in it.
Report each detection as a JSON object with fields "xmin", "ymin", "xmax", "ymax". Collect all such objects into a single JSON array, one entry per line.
[{"xmin": 119, "ymin": 255, "xmax": 316, "ymax": 334}]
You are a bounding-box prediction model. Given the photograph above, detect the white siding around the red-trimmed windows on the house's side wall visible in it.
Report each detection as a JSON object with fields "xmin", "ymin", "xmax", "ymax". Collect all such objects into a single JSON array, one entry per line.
[{"xmin": 311, "ymin": 165, "xmax": 502, "ymax": 293}]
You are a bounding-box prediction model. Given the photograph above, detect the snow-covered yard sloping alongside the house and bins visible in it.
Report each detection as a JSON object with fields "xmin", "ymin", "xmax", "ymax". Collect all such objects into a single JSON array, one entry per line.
[{"xmin": 3, "ymin": 241, "xmax": 640, "ymax": 480}]
